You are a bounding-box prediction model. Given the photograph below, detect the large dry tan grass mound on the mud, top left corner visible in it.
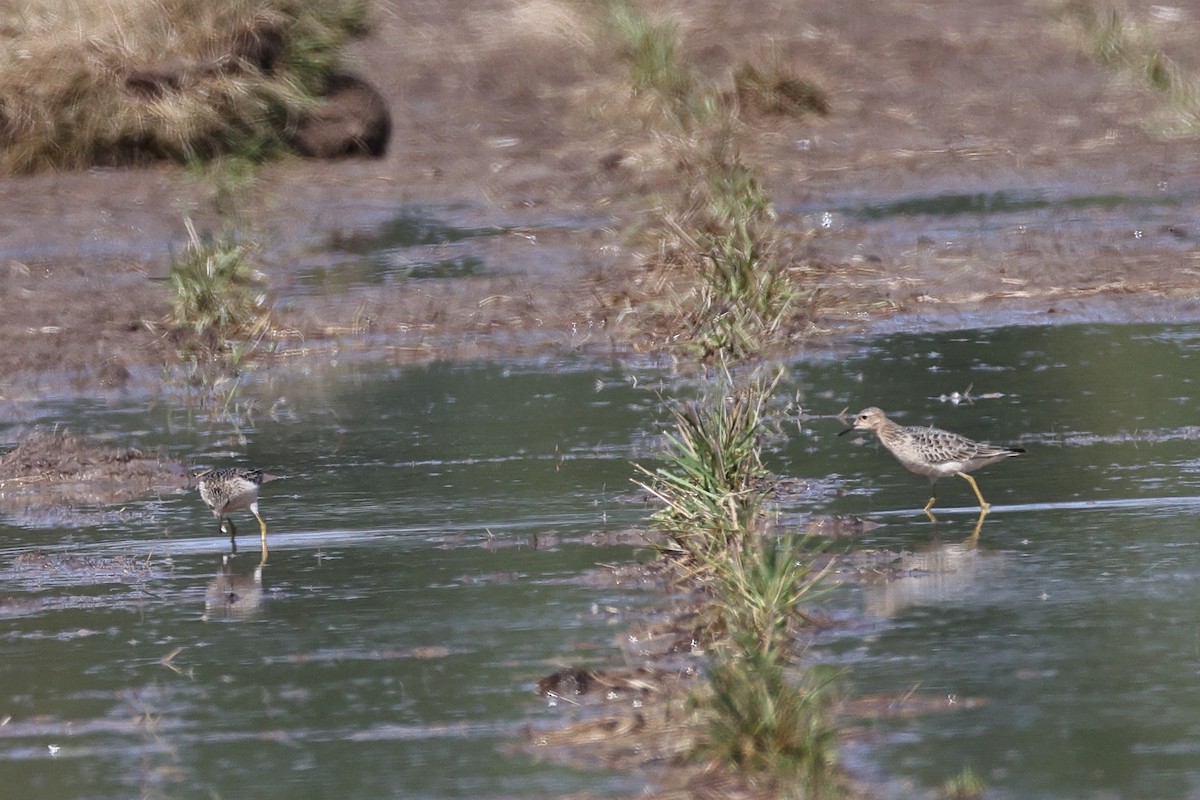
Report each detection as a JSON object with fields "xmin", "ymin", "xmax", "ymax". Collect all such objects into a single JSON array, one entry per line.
[{"xmin": 0, "ymin": 0, "xmax": 366, "ymax": 173}]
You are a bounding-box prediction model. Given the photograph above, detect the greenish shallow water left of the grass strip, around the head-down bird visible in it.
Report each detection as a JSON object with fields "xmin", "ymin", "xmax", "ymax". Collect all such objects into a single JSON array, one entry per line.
[{"xmin": 0, "ymin": 363, "xmax": 655, "ymax": 798}]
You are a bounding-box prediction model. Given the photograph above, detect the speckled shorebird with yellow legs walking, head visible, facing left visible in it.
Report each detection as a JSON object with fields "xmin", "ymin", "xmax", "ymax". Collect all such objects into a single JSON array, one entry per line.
[{"xmin": 838, "ymin": 407, "xmax": 1025, "ymax": 519}]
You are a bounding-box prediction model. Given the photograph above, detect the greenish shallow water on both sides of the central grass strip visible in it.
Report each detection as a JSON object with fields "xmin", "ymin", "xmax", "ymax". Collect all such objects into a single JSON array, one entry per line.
[{"xmin": 0, "ymin": 326, "xmax": 1200, "ymax": 800}]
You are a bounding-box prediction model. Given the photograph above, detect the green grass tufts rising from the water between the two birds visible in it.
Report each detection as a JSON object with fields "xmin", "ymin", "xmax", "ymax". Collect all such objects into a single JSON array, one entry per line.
[{"xmin": 640, "ymin": 373, "xmax": 838, "ymax": 798}]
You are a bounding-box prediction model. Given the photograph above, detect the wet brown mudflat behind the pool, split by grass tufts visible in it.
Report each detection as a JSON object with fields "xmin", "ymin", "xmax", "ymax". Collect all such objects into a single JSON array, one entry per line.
[{"xmin": 0, "ymin": 0, "xmax": 1200, "ymax": 401}]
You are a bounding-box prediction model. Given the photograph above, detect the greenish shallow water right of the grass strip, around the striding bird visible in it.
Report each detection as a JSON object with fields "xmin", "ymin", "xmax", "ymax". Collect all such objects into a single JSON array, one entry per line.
[{"xmin": 780, "ymin": 326, "xmax": 1200, "ymax": 799}]
